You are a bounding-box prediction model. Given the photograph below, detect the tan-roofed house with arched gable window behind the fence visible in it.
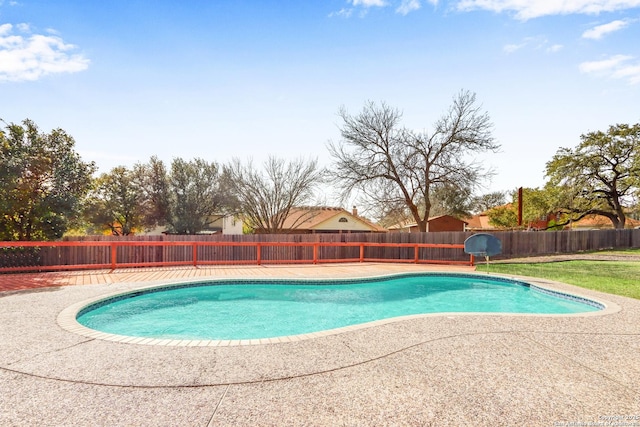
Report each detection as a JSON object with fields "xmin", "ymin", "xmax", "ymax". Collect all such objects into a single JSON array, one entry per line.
[{"xmin": 282, "ymin": 206, "xmax": 387, "ymax": 234}]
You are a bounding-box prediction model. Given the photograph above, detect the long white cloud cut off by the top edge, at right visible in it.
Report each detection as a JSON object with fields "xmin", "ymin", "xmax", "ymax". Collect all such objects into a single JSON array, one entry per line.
[{"xmin": 457, "ymin": 0, "xmax": 640, "ymax": 20}]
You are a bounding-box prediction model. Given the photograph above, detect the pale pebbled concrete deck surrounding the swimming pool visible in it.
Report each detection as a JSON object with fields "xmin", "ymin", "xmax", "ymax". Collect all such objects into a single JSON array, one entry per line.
[{"xmin": 0, "ymin": 264, "xmax": 640, "ymax": 426}]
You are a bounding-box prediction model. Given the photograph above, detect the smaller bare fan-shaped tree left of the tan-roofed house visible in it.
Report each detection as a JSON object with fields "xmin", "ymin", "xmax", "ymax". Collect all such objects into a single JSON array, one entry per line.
[{"xmin": 225, "ymin": 157, "xmax": 323, "ymax": 233}]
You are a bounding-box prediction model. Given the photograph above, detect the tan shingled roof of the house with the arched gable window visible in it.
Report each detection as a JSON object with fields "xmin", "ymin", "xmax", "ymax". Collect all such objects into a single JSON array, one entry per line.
[{"xmin": 282, "ymin": 206, "xmax": 387, "ymax": 232}]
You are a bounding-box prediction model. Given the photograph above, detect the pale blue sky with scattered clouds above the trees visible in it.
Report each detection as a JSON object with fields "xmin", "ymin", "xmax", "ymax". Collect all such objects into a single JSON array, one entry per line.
[{"xmin": 0, "ymin": 0, "xmax": 640, "ymax": 202}]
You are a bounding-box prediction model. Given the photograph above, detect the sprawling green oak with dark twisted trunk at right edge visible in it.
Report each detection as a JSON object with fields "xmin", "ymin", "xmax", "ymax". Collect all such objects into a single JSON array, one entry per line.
[{"xmin": 546, "ymin": 124, "xmax": 640, "ymax": 228}]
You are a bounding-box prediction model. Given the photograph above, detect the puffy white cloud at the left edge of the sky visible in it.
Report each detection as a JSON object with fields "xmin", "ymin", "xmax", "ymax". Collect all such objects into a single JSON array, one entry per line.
[{"xmin": 0, "ymin": 24, "xmax": 89, "ymax": 82}]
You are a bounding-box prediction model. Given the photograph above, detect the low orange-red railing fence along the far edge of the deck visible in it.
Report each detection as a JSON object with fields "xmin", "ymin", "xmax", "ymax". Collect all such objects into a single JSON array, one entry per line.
[{"xmin": 0, "ymin": 240, "xmax": 474, "ymax": 272}]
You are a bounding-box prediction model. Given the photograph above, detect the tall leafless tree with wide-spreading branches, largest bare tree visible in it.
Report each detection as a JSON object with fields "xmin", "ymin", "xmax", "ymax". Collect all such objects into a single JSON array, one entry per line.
[{"xmin": 328, "ymin": 91, "xmax": 499, "ymax": 231}]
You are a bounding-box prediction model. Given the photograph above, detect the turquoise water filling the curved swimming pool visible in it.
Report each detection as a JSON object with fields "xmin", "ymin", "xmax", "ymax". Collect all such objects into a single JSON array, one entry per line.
[{"xmin": 77, "ymin": 274, "xmax": 602, "ymax": 340}]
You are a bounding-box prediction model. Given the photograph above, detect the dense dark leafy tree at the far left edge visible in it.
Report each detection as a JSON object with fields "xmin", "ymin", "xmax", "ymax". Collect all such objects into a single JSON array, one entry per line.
[{"xmin": 0, "ymin": 119, "xmax": 95, "ymax": 240}]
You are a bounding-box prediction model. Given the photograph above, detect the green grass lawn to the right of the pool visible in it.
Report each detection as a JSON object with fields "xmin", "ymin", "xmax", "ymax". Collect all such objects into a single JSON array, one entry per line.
[{"xmin": 478, "ymin": 250, "xmax": 640, "ymax": 299}]
